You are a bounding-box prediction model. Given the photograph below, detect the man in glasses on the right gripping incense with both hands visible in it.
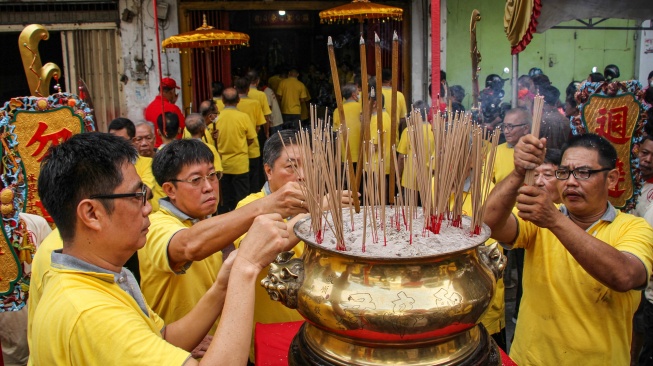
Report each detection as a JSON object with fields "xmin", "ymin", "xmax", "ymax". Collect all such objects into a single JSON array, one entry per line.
[{"xmin": 485, "ymin": 134, "xmax": 653, "ymax": 365}]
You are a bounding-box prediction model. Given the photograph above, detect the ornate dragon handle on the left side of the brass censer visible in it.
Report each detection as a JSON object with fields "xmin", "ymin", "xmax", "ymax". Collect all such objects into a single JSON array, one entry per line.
[{"xmin": 261, "ymin": 251, "xmax": 304, "ymax": 309}]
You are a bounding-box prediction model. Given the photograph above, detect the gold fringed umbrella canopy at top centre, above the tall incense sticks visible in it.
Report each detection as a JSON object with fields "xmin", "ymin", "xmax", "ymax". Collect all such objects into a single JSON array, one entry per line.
[{"xmin": 320, "ymin": 0, "xmax": 404, "ymax": 23}]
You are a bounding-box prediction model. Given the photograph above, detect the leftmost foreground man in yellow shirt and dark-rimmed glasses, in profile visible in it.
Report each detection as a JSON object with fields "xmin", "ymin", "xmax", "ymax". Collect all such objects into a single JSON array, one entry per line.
[{"xmin": 30, "ymin": 133, "xmax": 296, "ymax": 365}]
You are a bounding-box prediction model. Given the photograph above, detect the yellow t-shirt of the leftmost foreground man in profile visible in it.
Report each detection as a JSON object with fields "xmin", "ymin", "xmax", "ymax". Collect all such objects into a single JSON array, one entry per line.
[{"xmin": 30, "ymin": 258, "xmax": 190, "ymax": 365}]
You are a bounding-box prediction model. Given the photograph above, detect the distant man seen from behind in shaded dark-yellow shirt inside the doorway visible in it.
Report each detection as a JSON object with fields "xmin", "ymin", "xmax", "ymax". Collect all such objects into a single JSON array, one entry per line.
[{"xmin": 276, "ymin": 69, "xmax": 311, "ymax": 129}]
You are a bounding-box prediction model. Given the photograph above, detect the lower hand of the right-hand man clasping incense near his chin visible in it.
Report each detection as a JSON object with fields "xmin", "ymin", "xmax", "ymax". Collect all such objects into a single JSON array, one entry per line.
[{"xmin": 517, "ymin": 186, "xmax": 562, "ymax": 228}]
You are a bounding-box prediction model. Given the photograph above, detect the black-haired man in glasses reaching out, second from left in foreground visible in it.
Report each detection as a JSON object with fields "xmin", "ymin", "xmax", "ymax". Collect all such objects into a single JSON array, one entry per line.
[{"xmin": 138, "ymin": 139, "xmax": 306, "ymax": 342}]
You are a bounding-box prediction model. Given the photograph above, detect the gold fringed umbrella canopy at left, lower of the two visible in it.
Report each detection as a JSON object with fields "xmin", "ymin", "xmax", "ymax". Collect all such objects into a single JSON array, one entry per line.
[{"xmin": 161, "ymin": 15, "xmax": 249, "ymax": 49}]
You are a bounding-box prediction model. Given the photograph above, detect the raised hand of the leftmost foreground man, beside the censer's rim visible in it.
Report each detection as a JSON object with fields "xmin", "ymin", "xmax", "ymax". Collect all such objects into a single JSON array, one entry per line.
[{"xmin": 237, "ymin": 213, "xmax": 292, "ymax": 272}]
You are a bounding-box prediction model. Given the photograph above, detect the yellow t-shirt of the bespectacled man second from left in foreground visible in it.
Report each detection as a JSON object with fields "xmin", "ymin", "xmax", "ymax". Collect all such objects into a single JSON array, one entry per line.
[{"xmin": 138, "ymin": 201, "xmax": 222, "ymax": 334}]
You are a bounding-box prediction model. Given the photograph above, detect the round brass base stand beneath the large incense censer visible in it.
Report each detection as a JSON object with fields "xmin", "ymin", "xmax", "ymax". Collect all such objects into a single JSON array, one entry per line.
[{"xmin": 288, "ymin": 323, "xmax": 501, "ymax": 366}]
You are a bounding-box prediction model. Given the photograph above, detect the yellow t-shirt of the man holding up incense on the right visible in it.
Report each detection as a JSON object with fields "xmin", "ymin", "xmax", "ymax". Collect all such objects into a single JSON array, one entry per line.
[{"xmin": 510, "ymin": 205, "xmax": 653, "ymax": 366}]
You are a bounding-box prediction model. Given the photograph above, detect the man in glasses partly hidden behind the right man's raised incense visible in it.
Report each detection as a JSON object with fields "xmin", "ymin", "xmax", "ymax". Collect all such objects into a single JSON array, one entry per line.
[{"xmin": 492, "ymin": 107, "xmax": 533, "ymax": 184}]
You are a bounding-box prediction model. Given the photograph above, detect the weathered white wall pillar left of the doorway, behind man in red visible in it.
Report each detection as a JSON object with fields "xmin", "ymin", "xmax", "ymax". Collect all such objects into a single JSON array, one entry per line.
[{"xmin": 120, "ymin": 0, "xmax": 182, "ymax": 122}]
